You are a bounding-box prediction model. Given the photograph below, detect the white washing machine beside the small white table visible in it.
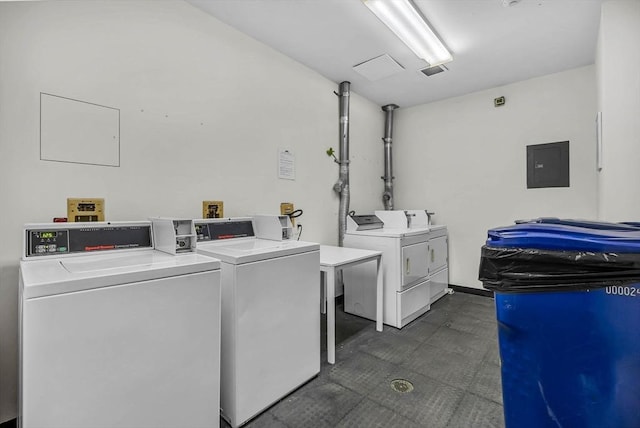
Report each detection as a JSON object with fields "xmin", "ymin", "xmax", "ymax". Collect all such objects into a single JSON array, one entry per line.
[{"xmin": 195, "ymin": 216, "xmax": 320, "ymax": 427}]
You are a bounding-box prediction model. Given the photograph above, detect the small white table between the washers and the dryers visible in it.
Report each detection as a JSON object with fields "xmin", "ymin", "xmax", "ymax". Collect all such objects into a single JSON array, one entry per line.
[{"xmin": 320, "ymin": 245, "xmax": 383, "ymax": 364}]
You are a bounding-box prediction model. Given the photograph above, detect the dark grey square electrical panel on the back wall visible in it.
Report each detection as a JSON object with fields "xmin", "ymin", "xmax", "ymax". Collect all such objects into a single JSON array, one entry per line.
[{"xmin": 527, "ymin": 141, "xmax": 569, "ymax": 189}]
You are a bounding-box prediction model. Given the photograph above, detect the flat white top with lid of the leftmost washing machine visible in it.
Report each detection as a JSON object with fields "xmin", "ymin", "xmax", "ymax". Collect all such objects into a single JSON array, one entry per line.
[{"xmin": 20, "ymin": 249, "xmax": 220, "ymax": 299}]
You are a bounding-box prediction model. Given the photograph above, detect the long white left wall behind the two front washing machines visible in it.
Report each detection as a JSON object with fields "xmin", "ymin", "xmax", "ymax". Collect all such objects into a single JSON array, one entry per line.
[{"xmin": 0, "ymin": 1, "xmax": 384, "ymax": 422}]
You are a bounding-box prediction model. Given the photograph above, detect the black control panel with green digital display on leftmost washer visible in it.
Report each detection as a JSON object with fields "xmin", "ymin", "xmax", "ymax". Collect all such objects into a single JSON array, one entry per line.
[{"xmin": 23, "ymin": 223, "xmax": 153, "ymax": 258}]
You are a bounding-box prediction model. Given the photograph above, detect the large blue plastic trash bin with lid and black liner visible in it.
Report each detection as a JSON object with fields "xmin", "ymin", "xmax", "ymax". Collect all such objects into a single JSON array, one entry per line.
[{"xmin": 480, "ymin": 221, "xmax": 640, "ymax": 428}]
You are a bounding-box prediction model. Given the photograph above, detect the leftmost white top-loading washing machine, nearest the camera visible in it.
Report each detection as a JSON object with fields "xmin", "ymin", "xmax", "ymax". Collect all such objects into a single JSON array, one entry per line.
[{"xmin": 18, "ymin": 222, "xmax": 220, "ymax": 428}]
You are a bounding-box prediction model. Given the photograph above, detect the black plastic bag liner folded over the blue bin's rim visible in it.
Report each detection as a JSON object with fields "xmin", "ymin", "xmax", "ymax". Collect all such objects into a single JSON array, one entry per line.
[{"xmin": 478, "ymin": 245, "xmax": 640, "ymax": 293}]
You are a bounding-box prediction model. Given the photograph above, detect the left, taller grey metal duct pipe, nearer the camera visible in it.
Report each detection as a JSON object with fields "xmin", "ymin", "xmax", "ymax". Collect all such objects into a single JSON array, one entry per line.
[{"xmin": 333, "ymin": 81, "xmax": 351, "ymax": 247}]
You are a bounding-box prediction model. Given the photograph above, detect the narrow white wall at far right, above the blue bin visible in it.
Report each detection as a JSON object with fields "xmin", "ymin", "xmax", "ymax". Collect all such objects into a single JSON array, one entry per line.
[{"xmin": 596, "ymin": 0, "xmax": 640, "ymax": 221}]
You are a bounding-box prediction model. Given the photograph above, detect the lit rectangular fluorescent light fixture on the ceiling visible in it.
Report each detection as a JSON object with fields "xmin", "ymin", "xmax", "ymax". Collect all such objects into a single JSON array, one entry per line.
[{"xmin": 362, "ymin": 0, "xmax": 453, "ymax": 66}]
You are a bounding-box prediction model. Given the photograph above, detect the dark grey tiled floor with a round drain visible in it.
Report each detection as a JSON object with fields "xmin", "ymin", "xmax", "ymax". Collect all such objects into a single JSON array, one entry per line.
[{"xmin": 221, "ymin": 292, "xmax": 504, "ymax": 428}]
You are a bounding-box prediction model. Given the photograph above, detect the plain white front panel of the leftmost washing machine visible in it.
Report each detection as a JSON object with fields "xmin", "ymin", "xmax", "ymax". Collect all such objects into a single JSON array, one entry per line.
[{"xmin": 21, "ymin": 271, "xmax": 220, "ymax": 428}]
